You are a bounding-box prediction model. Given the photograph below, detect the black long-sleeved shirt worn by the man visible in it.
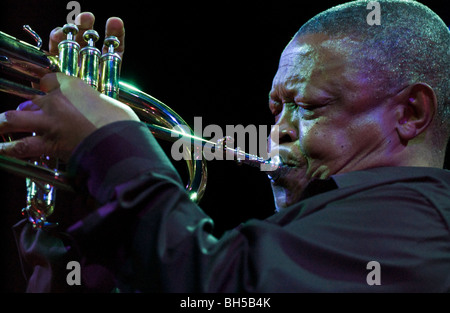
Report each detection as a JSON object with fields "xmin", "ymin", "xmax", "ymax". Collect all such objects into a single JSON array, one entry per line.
[{"xmin": 14, "ymin": 122, "xmax": 450, "ymax": 292}]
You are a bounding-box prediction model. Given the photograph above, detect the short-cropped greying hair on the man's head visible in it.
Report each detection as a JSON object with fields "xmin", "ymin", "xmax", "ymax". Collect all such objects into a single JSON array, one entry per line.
[{"xmin": 294, "ymin": 0, "xmax": 450, "ymax": 149}]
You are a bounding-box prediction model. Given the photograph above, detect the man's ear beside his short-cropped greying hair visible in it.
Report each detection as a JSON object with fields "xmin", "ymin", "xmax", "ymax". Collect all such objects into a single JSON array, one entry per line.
[{"xmin": 396, "ymin": 83, "xmax": 437, "ymax": 142}]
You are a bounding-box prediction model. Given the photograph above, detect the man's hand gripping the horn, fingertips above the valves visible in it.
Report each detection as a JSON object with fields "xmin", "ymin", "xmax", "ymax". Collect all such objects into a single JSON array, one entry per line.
[{"xmin": 0, "ymin": 13, "xmax": 139, "ymax": 160}]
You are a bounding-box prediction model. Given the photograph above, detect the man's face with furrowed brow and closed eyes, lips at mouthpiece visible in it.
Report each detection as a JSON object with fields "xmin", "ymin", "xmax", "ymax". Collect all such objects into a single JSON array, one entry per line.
[{"xmin": 269, "ymin": 34, "xmax": 395, "ymax": 209}]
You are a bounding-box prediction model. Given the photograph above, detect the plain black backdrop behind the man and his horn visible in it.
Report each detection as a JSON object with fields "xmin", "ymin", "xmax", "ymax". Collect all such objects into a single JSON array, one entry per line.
[{"xmin": 0, "ymin": 0, "xmax": 450, "ymax": 292}]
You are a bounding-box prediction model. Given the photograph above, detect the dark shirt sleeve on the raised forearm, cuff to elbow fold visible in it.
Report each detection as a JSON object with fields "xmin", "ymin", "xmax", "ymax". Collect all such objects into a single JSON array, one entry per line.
[{"xmin": 68, "ymin": 122, "xmax": 229, "ymax": 291}]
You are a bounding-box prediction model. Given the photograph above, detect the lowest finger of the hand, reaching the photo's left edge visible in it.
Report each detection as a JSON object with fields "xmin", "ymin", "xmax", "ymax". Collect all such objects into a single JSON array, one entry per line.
[{"xmin": 0, "ymin": 136, "xmax": 47, "ymax": 159}]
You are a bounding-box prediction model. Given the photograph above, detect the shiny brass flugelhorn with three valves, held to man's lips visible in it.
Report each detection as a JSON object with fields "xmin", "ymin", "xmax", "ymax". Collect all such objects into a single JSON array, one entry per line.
[{"xmin": 0, "ymin": 24, "xmax": 280, "ymax": 227}]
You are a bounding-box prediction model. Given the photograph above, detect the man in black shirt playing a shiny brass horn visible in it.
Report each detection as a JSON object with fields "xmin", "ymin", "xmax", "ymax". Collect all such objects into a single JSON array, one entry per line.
[{"xmin": 0, "ymin": 0, "xmax": 450, "ymax": 292}]
